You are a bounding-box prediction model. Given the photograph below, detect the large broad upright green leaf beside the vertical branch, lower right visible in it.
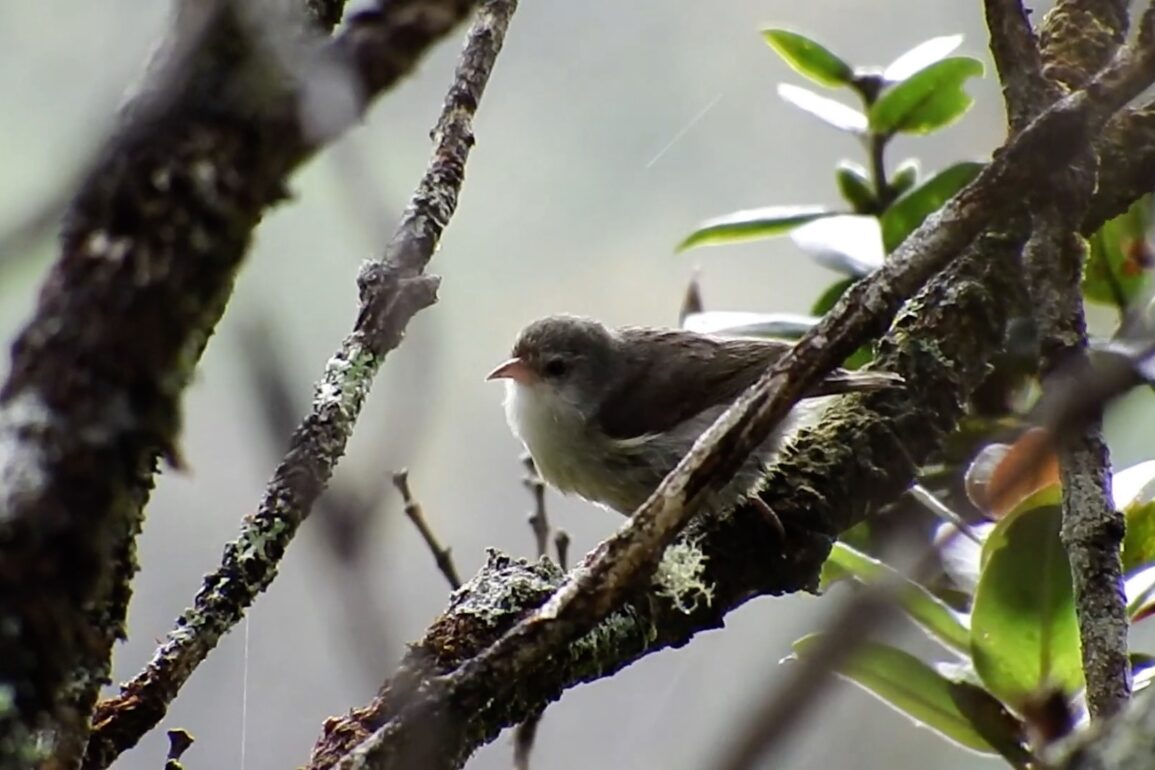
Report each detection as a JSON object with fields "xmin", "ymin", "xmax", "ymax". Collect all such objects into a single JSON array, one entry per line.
[{"xmin": 970, "ymin": 504, "xmax": 1082, "ymax": 703}]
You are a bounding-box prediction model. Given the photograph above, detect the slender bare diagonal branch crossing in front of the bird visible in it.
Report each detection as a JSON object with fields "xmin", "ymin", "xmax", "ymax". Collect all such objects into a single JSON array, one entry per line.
[{"xmin": 304, "ymin": 22, "xmax": 1155, "ymax": 768}]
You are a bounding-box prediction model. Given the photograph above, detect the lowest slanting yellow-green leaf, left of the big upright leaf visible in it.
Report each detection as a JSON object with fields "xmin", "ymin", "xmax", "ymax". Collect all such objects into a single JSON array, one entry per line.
[{"xmin": 793, "ymin": 634, "xmax": 997, "ymax": 754}]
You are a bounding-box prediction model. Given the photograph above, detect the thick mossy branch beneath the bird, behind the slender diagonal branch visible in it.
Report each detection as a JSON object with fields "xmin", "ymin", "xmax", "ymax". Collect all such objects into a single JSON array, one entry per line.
[{"xmin": 308, "ymin": 237, "xmax": 1020, "ymax": 769}]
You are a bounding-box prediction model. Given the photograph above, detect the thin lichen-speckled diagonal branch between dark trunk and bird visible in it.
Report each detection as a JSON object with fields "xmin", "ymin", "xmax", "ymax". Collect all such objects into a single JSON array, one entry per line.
[{"xmin": 85, "ymin": 0, "xmax": 515, "ymax": 769}]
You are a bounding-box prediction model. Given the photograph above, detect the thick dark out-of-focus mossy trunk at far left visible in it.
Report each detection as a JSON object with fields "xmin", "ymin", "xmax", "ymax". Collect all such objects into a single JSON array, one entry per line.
[{"xmin": 0, "ymin": 0, "xmax": 472, "ymax": 770}]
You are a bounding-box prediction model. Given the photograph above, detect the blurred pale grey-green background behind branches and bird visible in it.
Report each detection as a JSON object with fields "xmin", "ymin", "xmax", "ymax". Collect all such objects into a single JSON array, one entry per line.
[{"xmin": 0, "ymin": 0, "xmax": 1152, "ymax": 770}]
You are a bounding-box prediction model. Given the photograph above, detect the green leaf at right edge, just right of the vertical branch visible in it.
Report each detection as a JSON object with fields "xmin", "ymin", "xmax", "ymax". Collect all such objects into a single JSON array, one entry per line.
[{"xmin": 1082, "ymin": 193, "xmax": 1152, "ymax": 309}]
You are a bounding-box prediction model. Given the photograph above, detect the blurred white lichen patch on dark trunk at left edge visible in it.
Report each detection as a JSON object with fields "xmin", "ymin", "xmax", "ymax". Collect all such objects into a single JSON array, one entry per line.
[{"xmin": 0, "ymin": 391, "xmax": 52, "ymax": 522}]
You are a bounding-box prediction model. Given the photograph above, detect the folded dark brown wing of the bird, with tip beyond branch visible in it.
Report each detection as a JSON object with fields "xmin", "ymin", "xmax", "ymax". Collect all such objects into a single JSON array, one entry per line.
[{"xmin": 595, "ymin": 327, "xmax": 902, "ymax": 439}]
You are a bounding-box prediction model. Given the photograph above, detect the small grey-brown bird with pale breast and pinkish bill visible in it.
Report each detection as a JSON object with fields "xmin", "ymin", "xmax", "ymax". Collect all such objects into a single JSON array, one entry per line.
[{"xmin": 486, "ymin": 315, "xmax": 901, "ymax": 526}]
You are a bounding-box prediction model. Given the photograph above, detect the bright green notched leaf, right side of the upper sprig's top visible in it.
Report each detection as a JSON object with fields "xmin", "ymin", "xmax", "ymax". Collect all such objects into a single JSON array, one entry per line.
[{"xmin": 870, "ymin": 57, "xmax": 983, "ymax": 136}]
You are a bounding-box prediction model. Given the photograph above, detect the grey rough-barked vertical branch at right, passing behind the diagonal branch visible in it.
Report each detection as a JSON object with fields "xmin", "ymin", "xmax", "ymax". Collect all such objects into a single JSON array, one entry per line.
[{"xmin": 985, "ymin": 0, "xmax": 1136, "ymax": 717}]
